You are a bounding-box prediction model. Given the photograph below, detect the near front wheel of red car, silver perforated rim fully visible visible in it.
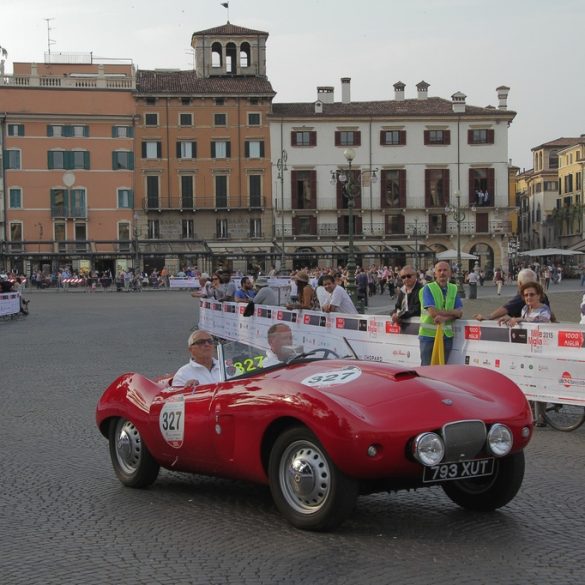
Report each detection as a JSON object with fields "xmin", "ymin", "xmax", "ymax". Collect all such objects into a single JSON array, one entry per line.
[{"xmin": 268, "ymin": 427, "xmax": 359, "ymax": 531}]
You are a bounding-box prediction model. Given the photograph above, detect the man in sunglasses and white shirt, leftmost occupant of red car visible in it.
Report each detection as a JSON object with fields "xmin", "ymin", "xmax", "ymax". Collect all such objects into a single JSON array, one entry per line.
[{"xmin": 172, "ymin": 329, "xmax": 220, "ymax": 388}]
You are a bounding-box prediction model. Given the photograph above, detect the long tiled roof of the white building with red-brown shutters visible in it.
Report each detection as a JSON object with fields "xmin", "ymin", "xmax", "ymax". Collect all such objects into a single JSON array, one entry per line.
[{"xmin": 272, "ymin": 97, "xmax": 516, "ymax": 118}]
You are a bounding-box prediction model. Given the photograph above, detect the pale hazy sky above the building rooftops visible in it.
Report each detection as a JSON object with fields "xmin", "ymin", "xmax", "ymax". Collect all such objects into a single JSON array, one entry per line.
[{"xmin": 0, "ymin": 0, "xmax": 585, "ymax": 168}]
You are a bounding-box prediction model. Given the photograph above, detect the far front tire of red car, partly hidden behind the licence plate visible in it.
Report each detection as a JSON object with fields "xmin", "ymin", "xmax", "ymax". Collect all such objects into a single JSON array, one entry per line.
[{"xmin": 442, "ymin": 451, "xmax": 524, "ymax": 512}]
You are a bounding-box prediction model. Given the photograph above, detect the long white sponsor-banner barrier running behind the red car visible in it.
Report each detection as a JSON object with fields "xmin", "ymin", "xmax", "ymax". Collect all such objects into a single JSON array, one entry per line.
[{"xmin": 199, "ymin": 299, "xmax": 585, "ymax": 406}]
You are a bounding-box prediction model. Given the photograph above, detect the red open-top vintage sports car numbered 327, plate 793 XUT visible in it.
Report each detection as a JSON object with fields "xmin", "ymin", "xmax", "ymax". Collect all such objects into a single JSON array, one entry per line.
[{"xmin": 96, "ymin": 343, "xmax": 533, "ymax": 530}]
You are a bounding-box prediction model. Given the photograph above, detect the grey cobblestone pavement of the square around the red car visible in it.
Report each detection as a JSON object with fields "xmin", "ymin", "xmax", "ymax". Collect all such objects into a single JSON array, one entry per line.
[{"xmin": 0, "ymin": 285, "xmax": 585, "ymax": 585}]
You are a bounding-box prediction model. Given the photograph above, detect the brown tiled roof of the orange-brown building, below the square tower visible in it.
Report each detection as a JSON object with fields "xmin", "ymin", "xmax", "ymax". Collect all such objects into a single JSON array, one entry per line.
[{"xmin": 136, "ymin": 70, "xmax": 276, "ymax": 96}]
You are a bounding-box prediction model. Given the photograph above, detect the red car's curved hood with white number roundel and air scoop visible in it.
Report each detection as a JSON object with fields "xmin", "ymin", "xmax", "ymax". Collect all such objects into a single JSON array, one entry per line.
[{"xmin": 262, "ymin": 360, "xmax": 526, "ymax": 428}]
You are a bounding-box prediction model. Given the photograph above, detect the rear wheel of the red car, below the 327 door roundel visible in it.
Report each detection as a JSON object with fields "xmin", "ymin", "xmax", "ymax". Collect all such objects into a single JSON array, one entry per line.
[{"xmin": 109, "ymin": 418, "xmax": 160, "ymax": 488}]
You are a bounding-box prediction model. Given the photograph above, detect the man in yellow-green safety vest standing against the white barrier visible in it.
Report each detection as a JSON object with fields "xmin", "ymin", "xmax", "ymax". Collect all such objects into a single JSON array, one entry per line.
[{"xmin": 418, "ymin": 261, "xmax": 463, "ymax": 366}]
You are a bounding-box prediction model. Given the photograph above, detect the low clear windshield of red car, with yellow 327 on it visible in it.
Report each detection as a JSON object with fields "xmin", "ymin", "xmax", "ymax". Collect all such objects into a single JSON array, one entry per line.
[{"xmin": 218, "ymin": 339, "xmax": 357, "ymax": 380}]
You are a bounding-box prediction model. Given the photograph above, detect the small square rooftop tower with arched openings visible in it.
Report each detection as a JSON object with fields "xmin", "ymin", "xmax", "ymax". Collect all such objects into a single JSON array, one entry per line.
[{"xmin": 191, "ymin": 21, "xmax": 268, "ymax": 79}]
